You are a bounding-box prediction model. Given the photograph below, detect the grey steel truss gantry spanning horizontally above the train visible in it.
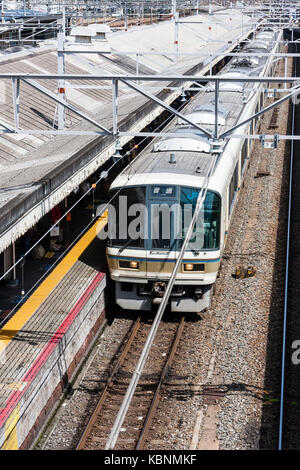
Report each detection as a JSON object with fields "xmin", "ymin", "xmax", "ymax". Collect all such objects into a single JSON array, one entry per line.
[{"xmin": 0, "ymin": 69, "xmax": 300, "ymax": 149}]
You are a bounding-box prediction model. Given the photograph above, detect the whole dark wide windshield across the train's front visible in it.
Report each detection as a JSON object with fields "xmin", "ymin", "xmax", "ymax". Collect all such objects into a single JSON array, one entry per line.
[{"xmin": 108, "ymin": 185, "xmax": 221, "ymax": 251}]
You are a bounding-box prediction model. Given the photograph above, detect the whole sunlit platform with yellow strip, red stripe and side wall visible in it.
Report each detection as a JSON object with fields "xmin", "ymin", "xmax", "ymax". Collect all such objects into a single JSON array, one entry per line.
[{"xmin": 0, "ymin": 217, "xmax": 106, "ymax": 450}]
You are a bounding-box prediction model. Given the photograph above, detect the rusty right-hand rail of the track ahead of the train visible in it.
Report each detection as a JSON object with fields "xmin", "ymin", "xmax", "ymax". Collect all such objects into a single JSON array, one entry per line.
[{"xmin": 135, "ymin": 317, "xmax": 185, "ymax": 450}]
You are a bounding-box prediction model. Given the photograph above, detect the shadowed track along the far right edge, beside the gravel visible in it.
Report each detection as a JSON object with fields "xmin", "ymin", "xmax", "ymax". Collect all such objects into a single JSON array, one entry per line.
[{"xmin": 278, "ymin": 38, "xmax": 300, "ymax": 450}]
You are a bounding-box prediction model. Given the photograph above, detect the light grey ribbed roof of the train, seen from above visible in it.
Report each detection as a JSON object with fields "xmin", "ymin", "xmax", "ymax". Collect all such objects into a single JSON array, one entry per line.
[{"xmin": 112, "ymin": 28, "xmax": 282, "ymax": 193}]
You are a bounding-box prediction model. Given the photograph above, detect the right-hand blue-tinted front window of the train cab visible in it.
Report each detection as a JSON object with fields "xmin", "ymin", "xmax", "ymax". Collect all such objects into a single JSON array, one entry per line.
[{"xmin": 179, "ymin": 187, "xmax": 221, "ymax": 250}]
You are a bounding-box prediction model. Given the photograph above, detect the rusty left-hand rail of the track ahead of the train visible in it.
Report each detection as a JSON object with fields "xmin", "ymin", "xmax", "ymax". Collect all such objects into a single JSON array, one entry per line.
[{"xmin": 76, "ymin": 317, "xmax": 141, "ymax": 450}]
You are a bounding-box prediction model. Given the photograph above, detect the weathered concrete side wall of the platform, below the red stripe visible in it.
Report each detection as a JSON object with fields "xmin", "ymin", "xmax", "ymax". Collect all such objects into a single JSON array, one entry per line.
[{"xmin": 0, "ymin": 274, "xmax": 106, "ymax": 450}]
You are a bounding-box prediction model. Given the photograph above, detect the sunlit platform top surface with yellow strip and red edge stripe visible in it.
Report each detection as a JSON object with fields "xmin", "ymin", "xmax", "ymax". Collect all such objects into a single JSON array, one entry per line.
[{"xmin": 0, "ymin": 216, "xmax": 106, "ymax": 450}]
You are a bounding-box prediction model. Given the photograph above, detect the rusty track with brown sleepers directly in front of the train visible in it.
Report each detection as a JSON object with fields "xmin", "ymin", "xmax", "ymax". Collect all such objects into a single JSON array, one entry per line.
[{"xmin": 77, "ymin": 317, "xmax": 185, "ymax": 450}]
